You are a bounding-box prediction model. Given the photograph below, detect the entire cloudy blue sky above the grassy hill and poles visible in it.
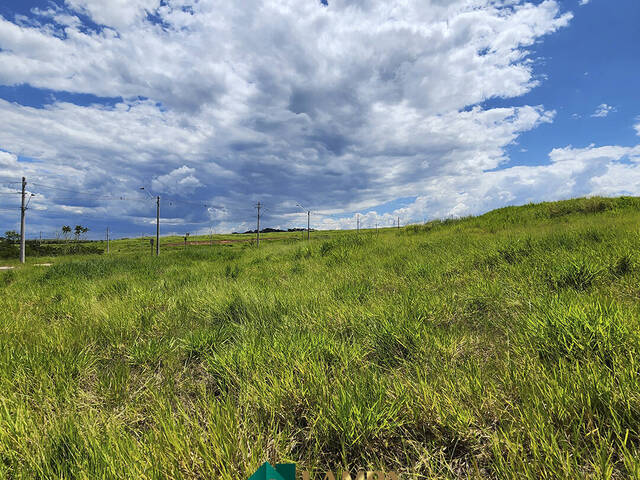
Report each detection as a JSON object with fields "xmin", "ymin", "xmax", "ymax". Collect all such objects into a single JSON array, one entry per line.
[{"xmin": 0, "ymin": 0, "xmax": 640, "ymax": 238}]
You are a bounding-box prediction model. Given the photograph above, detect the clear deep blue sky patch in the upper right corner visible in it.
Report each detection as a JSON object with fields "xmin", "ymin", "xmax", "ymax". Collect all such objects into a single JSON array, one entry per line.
[{"xmin": 487, "ymin": 0, "xmax": 640, "ymax": 165}]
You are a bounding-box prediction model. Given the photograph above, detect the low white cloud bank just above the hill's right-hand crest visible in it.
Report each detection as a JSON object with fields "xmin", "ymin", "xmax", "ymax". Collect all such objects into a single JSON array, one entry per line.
[{"xmin": 318, "ymin": 141, "xmax": 640, "ymax": 228}]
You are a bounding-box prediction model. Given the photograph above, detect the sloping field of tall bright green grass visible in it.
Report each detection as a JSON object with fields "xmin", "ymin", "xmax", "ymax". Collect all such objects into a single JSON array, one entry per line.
[{"xmin": 0, "ymin": 198, "xmax": 640, "ymax": 479}]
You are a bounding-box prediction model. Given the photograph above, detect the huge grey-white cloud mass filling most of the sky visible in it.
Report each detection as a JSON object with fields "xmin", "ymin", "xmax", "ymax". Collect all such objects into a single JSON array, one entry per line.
[{"xmin": 0, "ymin": 0, "xmax": 584, "ymax": 236}]
